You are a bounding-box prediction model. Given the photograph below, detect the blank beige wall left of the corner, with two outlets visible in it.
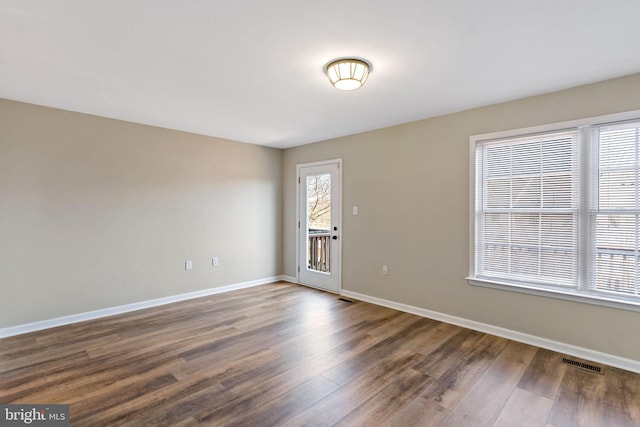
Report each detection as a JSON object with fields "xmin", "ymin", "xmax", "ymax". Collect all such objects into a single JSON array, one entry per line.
[{"xmin": 0, "ymin": 100, "xmax": 282, "ymax": 327}]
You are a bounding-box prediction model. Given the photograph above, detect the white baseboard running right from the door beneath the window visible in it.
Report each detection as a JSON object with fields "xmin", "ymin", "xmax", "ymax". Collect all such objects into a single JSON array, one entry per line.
[{"xmin": 340, "ymin": 289, "xmax": 640, "ymax": 373}]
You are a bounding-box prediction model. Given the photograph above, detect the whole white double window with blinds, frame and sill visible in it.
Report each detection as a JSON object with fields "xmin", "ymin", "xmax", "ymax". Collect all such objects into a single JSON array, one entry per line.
[{"xmin": 469, "ymin": 116, "xmax": 640, "ymax": 310}]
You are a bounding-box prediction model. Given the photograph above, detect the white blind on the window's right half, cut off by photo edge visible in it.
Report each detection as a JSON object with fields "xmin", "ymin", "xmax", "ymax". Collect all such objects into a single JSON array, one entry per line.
[{"xmin": 589, "ymin": 123, "xmax": 640, "ymax": 297}]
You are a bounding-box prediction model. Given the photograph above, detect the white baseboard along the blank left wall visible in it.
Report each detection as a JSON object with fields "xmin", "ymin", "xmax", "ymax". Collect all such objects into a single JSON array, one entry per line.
[{"xmin": 0, "ymin": 276, "xmax": 288, "ymax": 338}]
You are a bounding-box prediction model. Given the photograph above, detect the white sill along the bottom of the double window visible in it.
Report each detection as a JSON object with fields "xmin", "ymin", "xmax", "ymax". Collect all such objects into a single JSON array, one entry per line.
[{"xmin": 467, "ymin": 277, "xmax": 640, "ymax": 312}]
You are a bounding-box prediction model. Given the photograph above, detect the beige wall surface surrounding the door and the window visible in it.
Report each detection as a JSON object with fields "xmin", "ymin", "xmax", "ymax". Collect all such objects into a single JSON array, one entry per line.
[{"xmin": 283, "ymin": 74, "xmax": 640, "ymax": 360}]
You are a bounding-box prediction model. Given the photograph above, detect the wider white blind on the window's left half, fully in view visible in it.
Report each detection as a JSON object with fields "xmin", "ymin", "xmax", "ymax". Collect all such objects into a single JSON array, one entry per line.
[{"xmin": 475, "ymin": 130, "xmax": 580, "ymax": 288}]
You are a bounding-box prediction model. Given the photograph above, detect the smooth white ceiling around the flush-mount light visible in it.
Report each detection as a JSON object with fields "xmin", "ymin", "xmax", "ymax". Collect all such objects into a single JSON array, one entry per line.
[{"xmin": 0, "ymin": 0, "xmax": 640, "ymax": 148}]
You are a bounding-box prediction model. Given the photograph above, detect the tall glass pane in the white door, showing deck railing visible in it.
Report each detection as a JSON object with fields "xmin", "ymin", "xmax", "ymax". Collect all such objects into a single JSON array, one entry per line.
[{"xmin": 307, "ymin": 174, "xmax": 331, "ymax": 273}]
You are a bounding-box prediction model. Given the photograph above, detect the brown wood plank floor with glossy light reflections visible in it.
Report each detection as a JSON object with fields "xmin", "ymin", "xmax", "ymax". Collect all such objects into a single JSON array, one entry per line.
[{"xmin": 0, "ymin": 283, "xmax": 640, "ymax": 427}]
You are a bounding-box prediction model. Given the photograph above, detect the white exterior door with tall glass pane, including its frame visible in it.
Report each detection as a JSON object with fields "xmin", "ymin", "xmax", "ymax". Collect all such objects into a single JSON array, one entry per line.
[{"xmin": 298, "ymin": 160, "xmax": 342, "ymax": 293}]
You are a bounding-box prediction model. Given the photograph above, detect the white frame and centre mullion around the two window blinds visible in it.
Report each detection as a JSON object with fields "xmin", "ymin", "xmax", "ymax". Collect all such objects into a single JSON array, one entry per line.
[{"xmin": 467, "ymin": 110, "xmax": 640, "ymax": 311}]
